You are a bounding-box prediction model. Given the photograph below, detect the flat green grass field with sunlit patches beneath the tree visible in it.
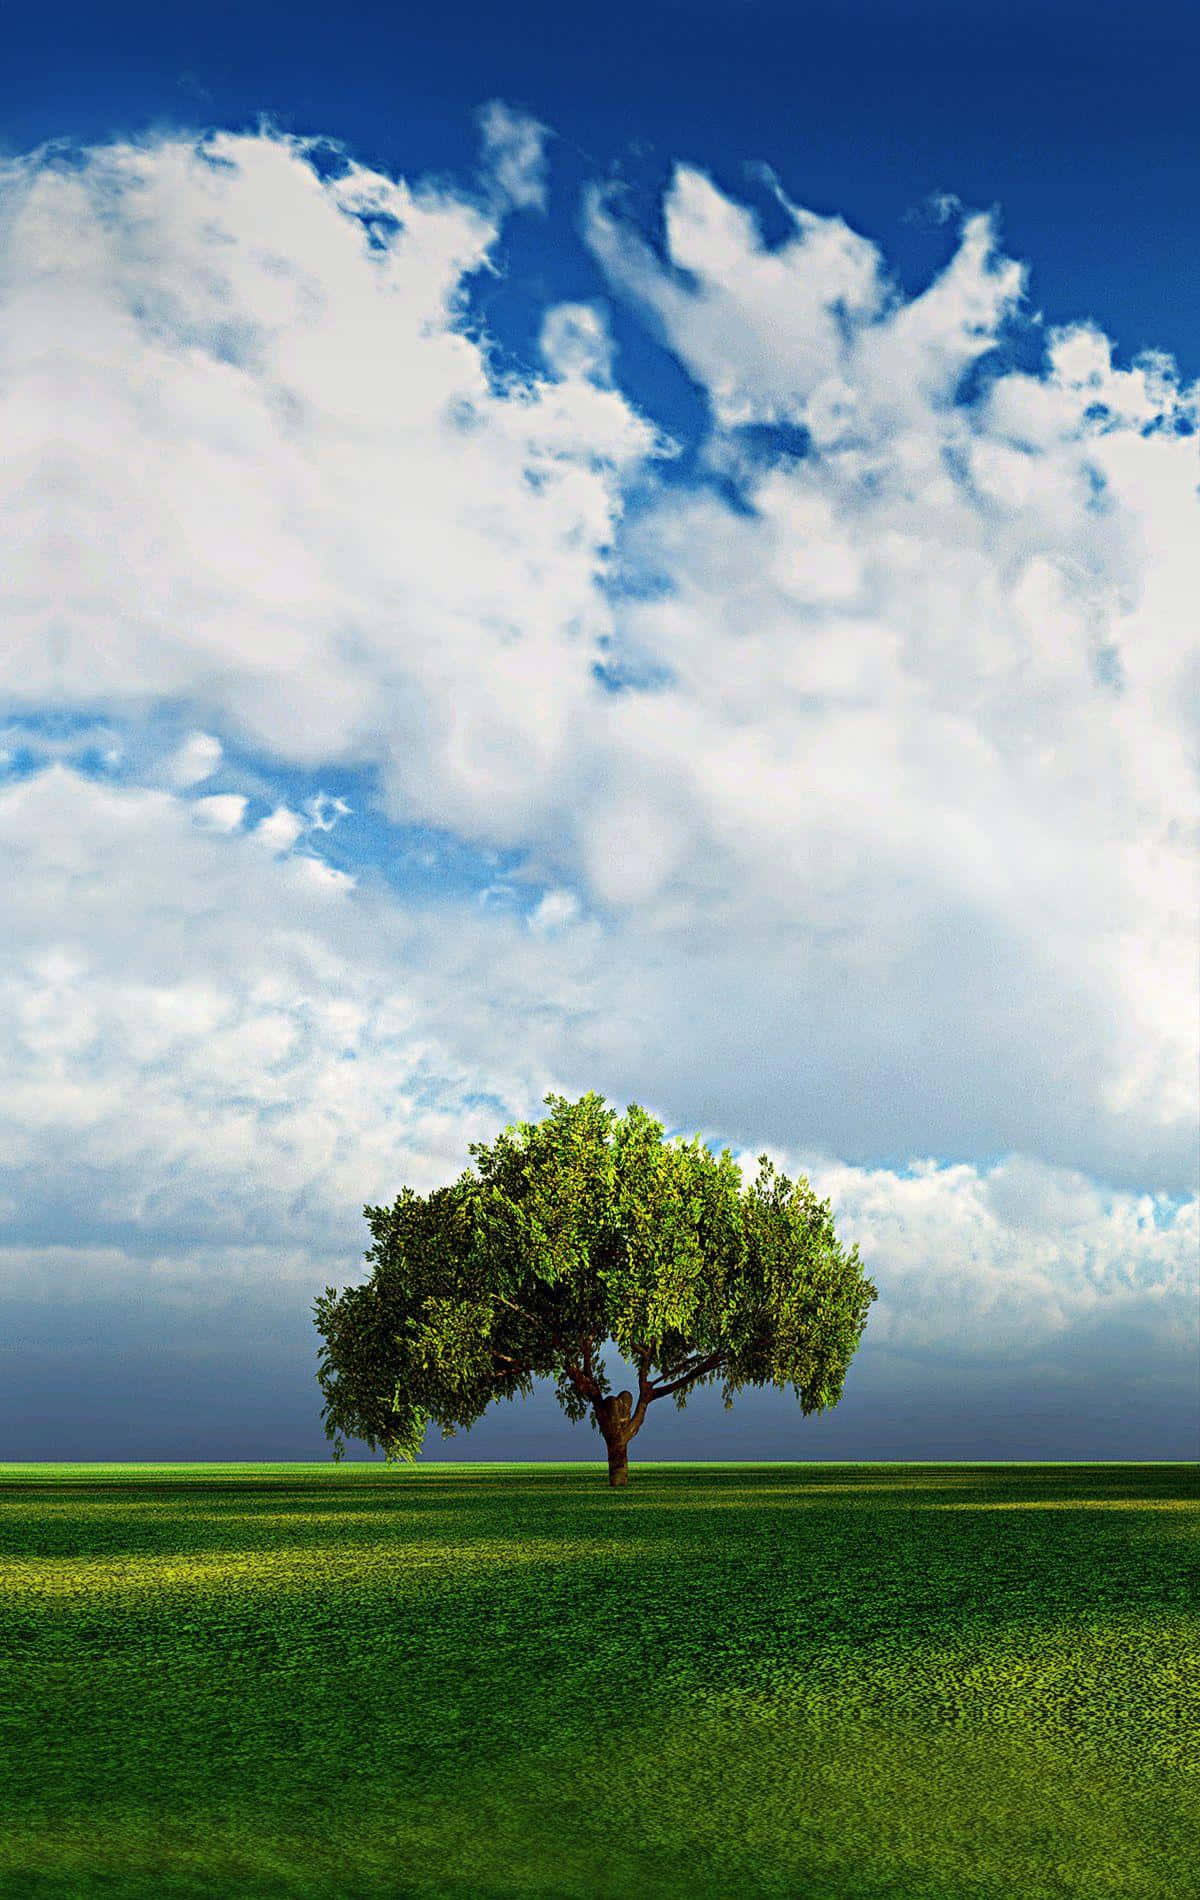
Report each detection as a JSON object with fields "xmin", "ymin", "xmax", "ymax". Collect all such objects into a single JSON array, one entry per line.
[{"xmin": 0, "ymin": 1463, "xmax": 1200, "ymax": 1900}]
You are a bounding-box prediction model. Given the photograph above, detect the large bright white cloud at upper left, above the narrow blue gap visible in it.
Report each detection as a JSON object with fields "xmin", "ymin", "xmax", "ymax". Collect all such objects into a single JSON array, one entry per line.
[{"xmin": 0, "ymin": 122, "xmax": 653, "ymax": 838}]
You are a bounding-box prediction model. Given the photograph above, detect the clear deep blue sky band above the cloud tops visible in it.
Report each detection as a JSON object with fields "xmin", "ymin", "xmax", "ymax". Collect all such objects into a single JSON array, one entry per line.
[{"xmin": 0, "ymin": 0, "xmax": 1200, "ymax": 393}]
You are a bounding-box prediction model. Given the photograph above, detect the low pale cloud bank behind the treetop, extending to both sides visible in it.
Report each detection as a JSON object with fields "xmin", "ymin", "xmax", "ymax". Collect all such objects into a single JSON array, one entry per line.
[{"xmin": 0, "ymin": 766, "xmax": 1198, "ymax": 1406}]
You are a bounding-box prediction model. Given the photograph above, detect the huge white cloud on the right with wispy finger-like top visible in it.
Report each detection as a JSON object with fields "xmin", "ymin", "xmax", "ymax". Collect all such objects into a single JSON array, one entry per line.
[{"xmin": 583, "ymin": 169, "xmax": 1200, "ymax": 1186}]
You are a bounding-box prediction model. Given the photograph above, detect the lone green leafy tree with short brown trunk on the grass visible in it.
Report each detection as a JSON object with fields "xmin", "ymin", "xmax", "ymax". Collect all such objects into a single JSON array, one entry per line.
[{"xmin": 315, "ymin": 1094, "xmax": 877, "ymax": 1486}]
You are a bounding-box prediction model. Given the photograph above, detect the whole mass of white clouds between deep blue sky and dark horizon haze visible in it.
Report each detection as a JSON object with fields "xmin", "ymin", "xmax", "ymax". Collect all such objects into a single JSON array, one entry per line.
[{"xmin": 0, "ymin": 130, "xmax": 1200, "ymax": 1436}]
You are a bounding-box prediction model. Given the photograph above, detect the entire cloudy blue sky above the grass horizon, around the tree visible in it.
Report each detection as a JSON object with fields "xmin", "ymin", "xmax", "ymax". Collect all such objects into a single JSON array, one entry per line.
[{"xmin": 0, "ymin": 0, "xmax": 1200, "ymax": 1461}]
